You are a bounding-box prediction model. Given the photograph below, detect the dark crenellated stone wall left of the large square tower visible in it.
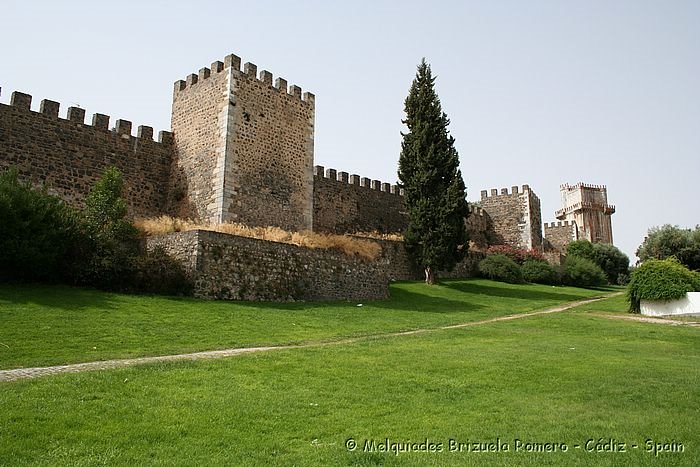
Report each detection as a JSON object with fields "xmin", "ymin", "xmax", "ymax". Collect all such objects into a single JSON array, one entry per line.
[{"xmin": 0, "ymin": 92, "xmax": 172, "ymax": 217}]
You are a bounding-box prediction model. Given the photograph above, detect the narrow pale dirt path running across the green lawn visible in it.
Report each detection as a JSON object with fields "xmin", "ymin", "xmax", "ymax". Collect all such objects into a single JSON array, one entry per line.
[{"xmin": 0, "ymin": 294, "xmax": 624, "ymax": 381}]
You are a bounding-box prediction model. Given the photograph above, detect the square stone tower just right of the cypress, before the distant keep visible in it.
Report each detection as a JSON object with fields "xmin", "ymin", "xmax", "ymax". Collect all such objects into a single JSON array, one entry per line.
[{"xmin": 479, "ymin": 185, "xmax": 542, "ymax": 250}]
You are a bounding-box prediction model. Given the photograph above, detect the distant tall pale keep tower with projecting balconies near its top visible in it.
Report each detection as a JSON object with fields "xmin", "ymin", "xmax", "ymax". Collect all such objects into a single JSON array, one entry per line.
[{"xmin": 556, "ymin": 183, "xmax": 615, "ymax": 244}]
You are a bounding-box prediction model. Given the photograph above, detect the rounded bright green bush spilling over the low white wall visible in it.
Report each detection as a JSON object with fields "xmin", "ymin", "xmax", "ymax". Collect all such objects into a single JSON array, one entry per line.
[{"xmin": 627, "ymin": 258, "xmax": 700, "ymax": 313}]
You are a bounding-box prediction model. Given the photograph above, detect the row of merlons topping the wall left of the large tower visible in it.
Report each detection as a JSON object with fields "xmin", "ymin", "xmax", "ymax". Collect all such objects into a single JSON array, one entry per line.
[{"xmin": 0, "ymin": 91, "xmax": 173, "ymax": 144}]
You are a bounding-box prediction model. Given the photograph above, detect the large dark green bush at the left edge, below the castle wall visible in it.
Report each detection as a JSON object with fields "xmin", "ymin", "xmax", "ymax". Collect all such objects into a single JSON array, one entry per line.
[{"xmin": 0, "ymin": 169, "xmax": 82, "ymax": 281}]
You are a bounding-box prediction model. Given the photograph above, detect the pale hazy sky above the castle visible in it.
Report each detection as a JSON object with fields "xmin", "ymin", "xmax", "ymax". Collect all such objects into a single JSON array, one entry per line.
[{"xmin": 0, "ymin": 0, "xmax": 700, "ymax": 260}]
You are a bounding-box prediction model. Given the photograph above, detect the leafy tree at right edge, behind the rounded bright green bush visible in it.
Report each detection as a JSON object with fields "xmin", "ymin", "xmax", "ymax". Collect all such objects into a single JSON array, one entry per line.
[{"xmin": 637, "ymin": 224, "xmax": 700, "ymax": 270}]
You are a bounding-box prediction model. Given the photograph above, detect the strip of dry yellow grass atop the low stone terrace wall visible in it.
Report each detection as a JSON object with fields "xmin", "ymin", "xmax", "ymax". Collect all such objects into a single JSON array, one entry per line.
[{"xmin": 134, "ymin": 216, "xmax": 381, "ymax": 260}]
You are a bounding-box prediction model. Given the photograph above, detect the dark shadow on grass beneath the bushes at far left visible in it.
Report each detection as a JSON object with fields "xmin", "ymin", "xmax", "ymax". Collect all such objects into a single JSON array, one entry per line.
[{"xmin": 0, "ymin": 283, "xmax": 120, "ymax": 311}]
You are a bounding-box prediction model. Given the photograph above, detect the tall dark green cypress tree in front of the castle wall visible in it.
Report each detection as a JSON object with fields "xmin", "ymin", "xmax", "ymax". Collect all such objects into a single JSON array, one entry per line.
[{"xmin": 399, "ymin": 58, "xmax": 469, "ymax": 284}]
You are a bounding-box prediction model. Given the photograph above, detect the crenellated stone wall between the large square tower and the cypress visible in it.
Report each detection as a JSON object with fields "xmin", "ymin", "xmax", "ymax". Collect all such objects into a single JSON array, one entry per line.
[{"xmin": 313, "ymin": 166, "xmax": 408, "ymax": 234}]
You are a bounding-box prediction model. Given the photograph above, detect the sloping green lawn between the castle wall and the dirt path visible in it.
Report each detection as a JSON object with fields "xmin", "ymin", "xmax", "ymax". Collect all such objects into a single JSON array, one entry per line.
[{"xmin": 0, "ymin": 280, "xmax": 605, "ymax": 369}]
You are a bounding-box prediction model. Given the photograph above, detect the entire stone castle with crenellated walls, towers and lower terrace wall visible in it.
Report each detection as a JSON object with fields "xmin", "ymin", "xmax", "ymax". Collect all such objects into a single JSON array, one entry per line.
[{"xmin": 0, "ymin": 49, "xmax": 600, "ymax": 300}]
